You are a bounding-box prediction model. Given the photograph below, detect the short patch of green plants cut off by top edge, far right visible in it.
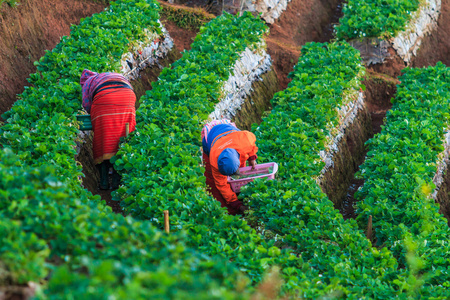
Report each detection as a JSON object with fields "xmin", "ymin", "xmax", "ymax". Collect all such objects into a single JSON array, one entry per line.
[{"xmin": 336, "ymin": 0, "xmax": 421, "ymax": 39}]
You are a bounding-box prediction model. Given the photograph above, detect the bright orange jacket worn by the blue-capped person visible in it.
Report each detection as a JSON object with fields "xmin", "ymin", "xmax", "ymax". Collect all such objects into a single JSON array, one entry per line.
[{"xmin": 209, "ymin": 130, "xmax": 258, "ymax": 203}]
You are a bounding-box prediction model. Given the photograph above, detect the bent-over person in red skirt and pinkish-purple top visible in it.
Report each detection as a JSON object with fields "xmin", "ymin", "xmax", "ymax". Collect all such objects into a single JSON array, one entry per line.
[{"xmin": 80, "ymin": 69, "xmax": 136, "ymax": 189}]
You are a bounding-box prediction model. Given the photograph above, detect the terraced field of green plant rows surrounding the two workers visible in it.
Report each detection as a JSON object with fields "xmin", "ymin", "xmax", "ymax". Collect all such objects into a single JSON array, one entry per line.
[{"xmin": 0, "ymin": 0, "xmax": 450, "ymax": 299}]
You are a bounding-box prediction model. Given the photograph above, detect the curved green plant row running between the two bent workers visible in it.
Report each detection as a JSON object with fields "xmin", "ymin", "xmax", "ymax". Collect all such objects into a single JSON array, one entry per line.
[{"xmin": 113, "ymin": 13, "xmax": 311, "ymax": 287}]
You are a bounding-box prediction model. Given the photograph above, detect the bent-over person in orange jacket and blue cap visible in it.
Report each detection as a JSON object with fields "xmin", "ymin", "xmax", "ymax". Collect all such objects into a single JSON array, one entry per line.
[{"xmin": 202, "ymin": 119, "xmax": 258, "ymax": 215}]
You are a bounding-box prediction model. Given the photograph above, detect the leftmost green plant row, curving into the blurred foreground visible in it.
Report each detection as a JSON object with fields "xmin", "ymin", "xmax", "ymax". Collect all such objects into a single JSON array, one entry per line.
[{"xmin": 0, "ymin": 0, "xmax": 249, "ymax": 299}]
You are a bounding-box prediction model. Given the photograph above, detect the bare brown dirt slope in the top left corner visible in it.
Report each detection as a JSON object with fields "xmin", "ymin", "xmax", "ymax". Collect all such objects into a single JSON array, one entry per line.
[{"xmin": 0, "ymin": 0, "xmax": 105, "ymax": 119}]
